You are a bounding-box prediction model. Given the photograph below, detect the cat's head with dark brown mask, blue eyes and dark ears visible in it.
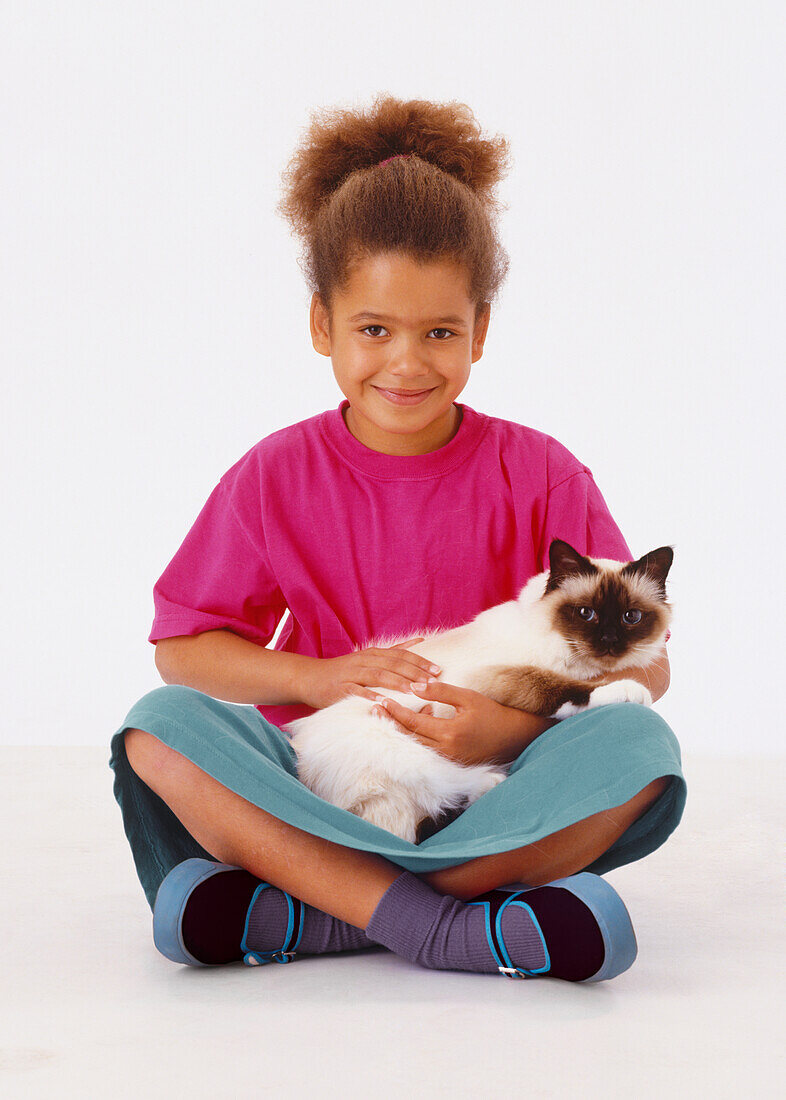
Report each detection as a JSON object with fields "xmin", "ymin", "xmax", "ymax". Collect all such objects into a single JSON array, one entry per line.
[{"xmin": 543, "ymin": 539, "xmax": 674, "ymax": 671}]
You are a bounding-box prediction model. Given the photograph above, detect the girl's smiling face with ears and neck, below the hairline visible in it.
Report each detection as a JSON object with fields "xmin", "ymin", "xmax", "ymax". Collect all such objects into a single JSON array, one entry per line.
[{"xmin": 310, "ymin": 253, "xmax": 490, "ymax": 454}]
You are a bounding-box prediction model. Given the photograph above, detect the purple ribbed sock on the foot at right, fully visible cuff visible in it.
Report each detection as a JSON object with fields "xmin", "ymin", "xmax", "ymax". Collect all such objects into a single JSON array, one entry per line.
[{"xmin": 366, "ymin": 871, "xmax": 560, "ymax": 977}]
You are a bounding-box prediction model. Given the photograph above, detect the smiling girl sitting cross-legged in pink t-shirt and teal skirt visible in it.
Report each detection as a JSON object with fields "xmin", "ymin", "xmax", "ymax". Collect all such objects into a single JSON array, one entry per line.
[{"xmin": 110, "ymin": 96, "xmax": 686, "ymax": 981}]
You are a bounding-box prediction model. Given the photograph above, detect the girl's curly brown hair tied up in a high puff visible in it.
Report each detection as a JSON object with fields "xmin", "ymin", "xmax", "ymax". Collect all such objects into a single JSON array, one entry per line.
[{"xmin": 276, "ymin": 94, "xmax": 511, "ymax": 319}]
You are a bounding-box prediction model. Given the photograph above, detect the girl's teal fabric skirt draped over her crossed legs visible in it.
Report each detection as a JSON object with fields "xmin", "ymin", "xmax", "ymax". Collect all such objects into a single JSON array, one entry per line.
[{"xmin": 109, "ymin": 684, "xmax": 687, "ymax": 909}]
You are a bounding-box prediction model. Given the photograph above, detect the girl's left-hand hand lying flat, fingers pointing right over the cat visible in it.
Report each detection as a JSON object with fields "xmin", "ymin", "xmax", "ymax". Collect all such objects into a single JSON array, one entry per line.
[{"xmin": 302, "ymin": 635, "xmax": 441, "ymax": 710}]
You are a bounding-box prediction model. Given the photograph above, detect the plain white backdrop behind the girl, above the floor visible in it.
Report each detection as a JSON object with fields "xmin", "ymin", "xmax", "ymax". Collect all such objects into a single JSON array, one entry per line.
[{"xmin": 0, "ymin": 0, "xmax": 786, "ymax": 756}]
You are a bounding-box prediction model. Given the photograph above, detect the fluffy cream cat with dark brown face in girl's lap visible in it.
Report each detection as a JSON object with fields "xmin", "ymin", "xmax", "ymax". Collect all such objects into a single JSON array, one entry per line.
[{"xmin": 284, "ymin": 539, "xmax": 674, "ymax": 844}]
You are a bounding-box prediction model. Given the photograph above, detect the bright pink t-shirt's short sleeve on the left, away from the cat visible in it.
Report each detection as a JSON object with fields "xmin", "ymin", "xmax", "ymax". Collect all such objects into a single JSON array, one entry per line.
[{"xmin": 147, "ymin": 479, "xmax": 287, "ymax": 646}]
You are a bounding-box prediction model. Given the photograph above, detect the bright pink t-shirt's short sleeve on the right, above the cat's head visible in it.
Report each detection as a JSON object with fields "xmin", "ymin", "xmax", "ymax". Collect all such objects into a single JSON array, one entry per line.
[{"xmin": 539, "ymin": 466, "xmax": 633, "ymax": 570}]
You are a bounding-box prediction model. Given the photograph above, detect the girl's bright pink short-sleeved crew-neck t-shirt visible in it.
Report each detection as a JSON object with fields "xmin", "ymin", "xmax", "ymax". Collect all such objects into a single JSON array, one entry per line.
[{"xmin": 148, "ymin": 398, "xmax": 633, "ymax": 726}]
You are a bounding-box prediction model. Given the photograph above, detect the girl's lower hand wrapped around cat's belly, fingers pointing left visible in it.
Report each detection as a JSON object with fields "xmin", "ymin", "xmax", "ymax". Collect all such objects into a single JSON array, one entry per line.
[{"xmin": 374, "ymin": 680, "xmax": 538, "ymax": 765}]
